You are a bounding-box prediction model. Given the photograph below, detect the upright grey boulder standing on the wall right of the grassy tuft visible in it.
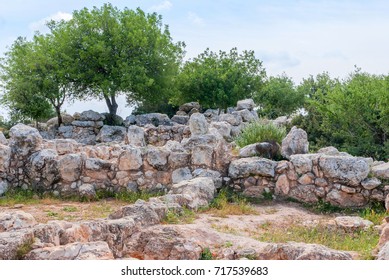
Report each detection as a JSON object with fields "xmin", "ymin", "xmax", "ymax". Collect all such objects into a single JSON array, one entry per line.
[{"xmin": 281, "ymin": 126, "xmax": 309, "ymax": 159}]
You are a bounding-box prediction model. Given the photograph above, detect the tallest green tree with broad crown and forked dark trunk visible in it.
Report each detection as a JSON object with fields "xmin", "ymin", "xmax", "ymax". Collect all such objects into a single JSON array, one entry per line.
[{"xmin": 53, "ymin": 4, "xmax": 184, "ymax": 118}]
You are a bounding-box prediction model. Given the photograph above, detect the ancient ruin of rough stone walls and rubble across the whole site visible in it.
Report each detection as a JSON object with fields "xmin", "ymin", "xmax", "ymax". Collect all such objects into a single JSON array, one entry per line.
[{"xmin": 0, "ymin": 100, "xmax": 389, "ymax": 259}]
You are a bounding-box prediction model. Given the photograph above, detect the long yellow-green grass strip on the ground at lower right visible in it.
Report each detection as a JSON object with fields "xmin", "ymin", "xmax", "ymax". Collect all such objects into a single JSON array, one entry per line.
[{"xmin": 254, "ymin": 225, "xmax": 379, "ymax": 259}]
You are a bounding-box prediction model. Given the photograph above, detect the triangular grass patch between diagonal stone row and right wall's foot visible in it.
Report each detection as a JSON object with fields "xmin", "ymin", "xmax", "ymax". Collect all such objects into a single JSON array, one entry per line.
[{"xmin": 206, "ymin": 189, "xmax": 258, "ymax": 218}]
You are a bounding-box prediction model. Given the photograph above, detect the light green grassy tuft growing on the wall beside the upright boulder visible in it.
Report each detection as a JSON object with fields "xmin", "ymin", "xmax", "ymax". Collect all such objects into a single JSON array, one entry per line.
[{"xmin": 235, "ymin": 121, "xmax": 286, "ymax": 147}]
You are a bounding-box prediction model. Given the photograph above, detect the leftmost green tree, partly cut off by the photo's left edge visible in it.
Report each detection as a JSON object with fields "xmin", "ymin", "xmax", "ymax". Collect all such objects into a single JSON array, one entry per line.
[{"xmin": 1, "ymin": 37, "xmax": 53, "ymax": 125}]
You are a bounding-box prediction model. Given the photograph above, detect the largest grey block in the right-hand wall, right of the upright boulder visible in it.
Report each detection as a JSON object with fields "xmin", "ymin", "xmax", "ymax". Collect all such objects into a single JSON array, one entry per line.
[{"xmin": 319, "ymin": 155, "xmax": 370, "ymax": 186}]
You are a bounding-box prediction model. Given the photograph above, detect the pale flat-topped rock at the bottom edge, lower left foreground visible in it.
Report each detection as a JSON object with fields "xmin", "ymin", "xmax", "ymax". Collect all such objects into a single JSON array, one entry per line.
[{"xmin": 26, "ymin": 241, "xmax": 114, "ymax": 260}]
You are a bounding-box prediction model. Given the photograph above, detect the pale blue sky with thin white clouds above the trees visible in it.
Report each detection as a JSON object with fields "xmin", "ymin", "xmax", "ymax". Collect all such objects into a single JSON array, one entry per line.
[{"xmin": 0, "ymin": 0, "xmax": 389, "ymax": 116}]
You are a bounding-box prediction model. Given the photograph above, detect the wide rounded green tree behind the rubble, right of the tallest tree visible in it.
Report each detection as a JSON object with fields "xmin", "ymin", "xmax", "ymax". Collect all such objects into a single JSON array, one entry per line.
[{"xmin": 172, "ymin": 48, "xmax": 265, "ymax": 110}]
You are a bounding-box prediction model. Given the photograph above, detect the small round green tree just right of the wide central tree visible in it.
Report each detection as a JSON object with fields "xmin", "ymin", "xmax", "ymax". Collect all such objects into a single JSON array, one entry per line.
[{"xmin": 254, "ymin": 74, "xmax": 304, "ymax": 119}]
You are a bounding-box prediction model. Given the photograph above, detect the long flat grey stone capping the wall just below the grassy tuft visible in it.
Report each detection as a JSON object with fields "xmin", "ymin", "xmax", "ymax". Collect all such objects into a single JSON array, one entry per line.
[{"xmin": 228, "ymin": 157, "xmax": 277, "ymax": 179}]
